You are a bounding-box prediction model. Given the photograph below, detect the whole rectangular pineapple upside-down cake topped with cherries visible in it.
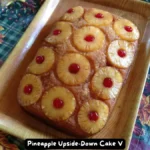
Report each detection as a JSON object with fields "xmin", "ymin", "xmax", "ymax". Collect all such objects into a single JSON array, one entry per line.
[{"xmin": 18, "ymin": 6, "xmax": 140, "ymax": 136}]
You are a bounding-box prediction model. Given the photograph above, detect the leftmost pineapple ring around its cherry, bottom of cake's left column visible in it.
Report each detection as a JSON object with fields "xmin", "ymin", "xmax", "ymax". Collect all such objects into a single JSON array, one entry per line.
[{"xmin": 18, "ymin": 74, "xmax": 43, "ymax": 106}]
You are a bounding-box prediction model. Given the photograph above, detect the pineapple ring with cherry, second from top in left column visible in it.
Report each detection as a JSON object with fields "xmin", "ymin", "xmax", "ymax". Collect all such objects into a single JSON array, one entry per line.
[{"xmin": 45, "ymin": 21, "xmax": 72, "ymax": 45}]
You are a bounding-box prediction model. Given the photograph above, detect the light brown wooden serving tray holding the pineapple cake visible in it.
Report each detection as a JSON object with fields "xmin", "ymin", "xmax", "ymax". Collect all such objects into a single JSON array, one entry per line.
[{"xmin": 0, "ymin": 0, "xmax": 150, "ymax": 149}]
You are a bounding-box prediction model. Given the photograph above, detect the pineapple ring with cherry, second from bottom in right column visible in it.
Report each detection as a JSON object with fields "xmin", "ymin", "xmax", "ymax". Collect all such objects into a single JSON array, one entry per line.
[{"xmin": 91, "ymin": 67, "xmax": 123, "ymax": 100}]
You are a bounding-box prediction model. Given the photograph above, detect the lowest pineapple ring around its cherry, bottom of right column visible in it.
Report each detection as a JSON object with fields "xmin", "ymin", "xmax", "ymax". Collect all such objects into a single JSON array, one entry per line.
[{"xmin": 78, "ymin": 99, "xmax": 109, "ymax": 134}]
